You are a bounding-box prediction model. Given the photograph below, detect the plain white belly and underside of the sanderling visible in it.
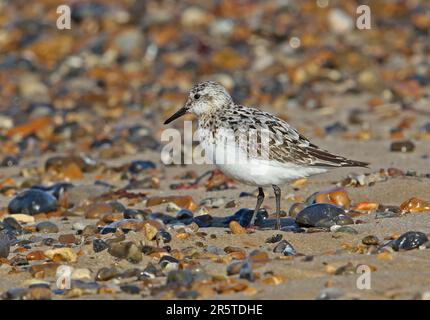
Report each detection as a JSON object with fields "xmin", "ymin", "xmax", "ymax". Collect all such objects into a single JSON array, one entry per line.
[{"xmin": 196, "ymin": 127, "xmax": 327, "ymax": 187}]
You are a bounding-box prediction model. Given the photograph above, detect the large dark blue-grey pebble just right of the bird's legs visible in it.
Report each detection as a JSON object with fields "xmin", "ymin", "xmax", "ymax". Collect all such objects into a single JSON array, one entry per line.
[{"xmin": 296, "ymin": 203, "xmax": 354, "ymax": 228}]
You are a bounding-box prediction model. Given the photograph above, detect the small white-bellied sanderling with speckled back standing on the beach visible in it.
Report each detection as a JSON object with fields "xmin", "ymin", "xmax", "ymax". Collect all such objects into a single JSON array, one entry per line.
[{"xmin": 164, "ymin": 81, "xmax": 368, "ymax": 229}]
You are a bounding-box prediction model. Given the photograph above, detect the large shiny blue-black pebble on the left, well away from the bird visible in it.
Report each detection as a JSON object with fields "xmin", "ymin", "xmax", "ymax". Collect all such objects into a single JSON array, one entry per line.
[{"xmin": 8, "ymin": 189, "xmax": 58, "ymax": 215}]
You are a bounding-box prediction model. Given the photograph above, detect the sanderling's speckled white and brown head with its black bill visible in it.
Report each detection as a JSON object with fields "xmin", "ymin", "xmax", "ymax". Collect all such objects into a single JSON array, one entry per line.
[{"xmin": 164, "ymin": 81, "xmax": 232, "ymax": 124}]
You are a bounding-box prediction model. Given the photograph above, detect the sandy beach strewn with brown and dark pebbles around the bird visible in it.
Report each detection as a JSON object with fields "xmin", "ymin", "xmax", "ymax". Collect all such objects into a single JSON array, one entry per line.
[{"xmin": 0, "ymin": 0, "xmax": 430, "ymax": 300}]
